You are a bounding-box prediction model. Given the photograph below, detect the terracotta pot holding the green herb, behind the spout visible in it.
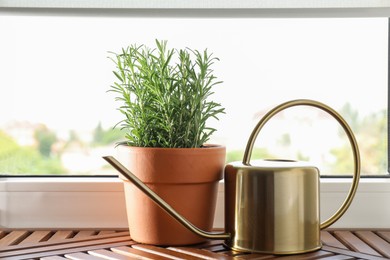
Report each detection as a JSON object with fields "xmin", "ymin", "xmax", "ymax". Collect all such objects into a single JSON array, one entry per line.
[{"xmin": 118, "ymin": 145, "xmax": 226, "ymax": 246}]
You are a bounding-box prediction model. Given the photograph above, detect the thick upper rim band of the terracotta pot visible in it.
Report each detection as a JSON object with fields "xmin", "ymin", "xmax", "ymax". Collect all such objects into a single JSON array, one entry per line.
[{"xmin": 117, "ymin": 145, "xmax": 226, "ymax": 184}]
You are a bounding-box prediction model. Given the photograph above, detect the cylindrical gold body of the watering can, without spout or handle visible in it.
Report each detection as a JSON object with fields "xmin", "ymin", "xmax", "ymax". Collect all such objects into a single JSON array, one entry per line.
[{"xmin": 225, "ymin": 161, "xmax": 321, "ymax": 254}]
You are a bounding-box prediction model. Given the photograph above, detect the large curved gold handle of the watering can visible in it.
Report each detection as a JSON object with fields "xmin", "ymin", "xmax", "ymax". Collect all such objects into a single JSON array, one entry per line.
[{"xmin": 242, "ymin": 99, "xmax": 360, "ymax": 229}]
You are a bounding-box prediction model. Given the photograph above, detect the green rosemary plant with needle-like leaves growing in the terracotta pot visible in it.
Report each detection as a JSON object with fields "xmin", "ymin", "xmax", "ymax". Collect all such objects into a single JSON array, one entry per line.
[{"xmin": 110, "ymin": 40, "xmax": 224, "ymax": 148}]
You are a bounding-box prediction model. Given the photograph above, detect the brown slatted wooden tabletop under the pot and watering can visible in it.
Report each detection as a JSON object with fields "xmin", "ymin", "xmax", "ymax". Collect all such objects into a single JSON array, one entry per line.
[{"xmin": 0, "ymin": 229, "xmax": 390, "ymax": 260}]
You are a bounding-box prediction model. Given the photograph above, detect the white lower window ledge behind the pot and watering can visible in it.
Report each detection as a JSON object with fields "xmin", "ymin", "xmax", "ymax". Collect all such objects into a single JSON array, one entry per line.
[{"xmin": 0, "ymin": 177, "xmax": 390, "ymax": 229}]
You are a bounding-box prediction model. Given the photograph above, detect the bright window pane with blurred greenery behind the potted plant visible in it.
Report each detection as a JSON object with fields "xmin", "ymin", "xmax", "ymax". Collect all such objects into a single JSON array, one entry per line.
[{"xmin": 0, "ymin": 15, "xmax": 388, "ymax": 175}]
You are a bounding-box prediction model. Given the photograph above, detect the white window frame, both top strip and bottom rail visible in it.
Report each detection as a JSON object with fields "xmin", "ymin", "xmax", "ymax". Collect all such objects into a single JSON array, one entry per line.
[{"xmin": 0, "ymin": 0, "xmax": 390, "ymax": 229}]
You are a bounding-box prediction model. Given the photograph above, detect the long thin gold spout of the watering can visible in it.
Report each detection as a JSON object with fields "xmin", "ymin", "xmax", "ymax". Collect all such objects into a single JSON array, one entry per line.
[{"xmin": 103, "ymin": 156, "xmax": 231, "ymax": 240}]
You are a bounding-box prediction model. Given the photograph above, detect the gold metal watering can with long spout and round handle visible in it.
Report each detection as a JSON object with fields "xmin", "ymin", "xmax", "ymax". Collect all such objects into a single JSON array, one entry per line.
[{"xmin": 103, "ymin": 100, "xmax": 360, "ymax": 254}]
